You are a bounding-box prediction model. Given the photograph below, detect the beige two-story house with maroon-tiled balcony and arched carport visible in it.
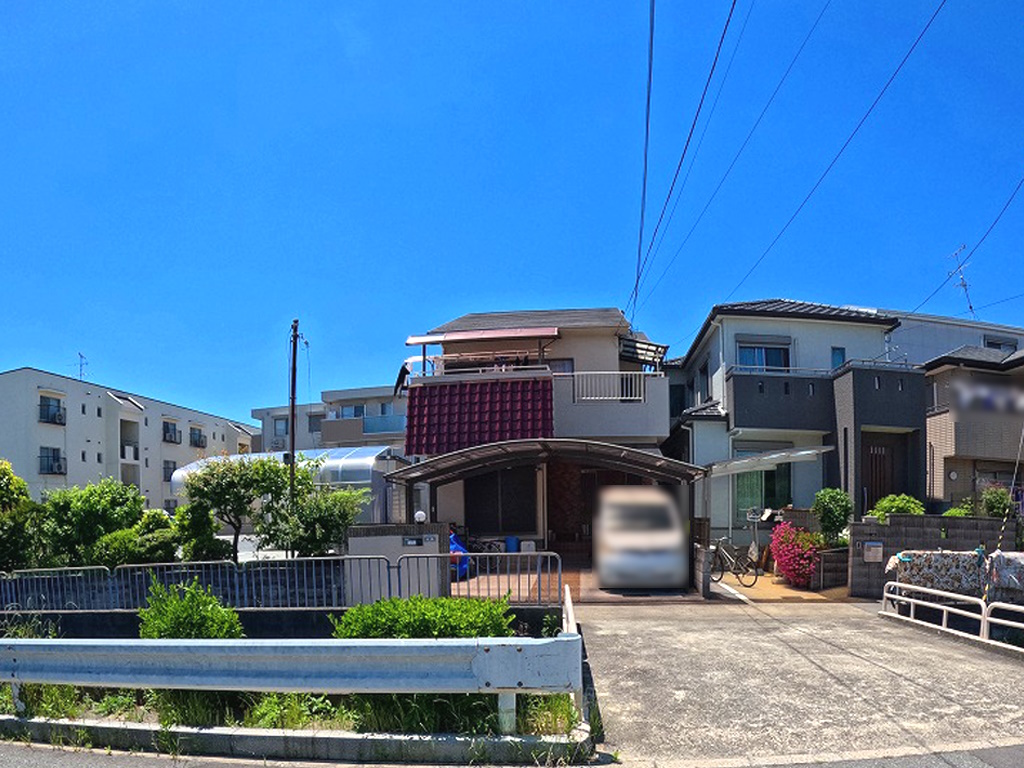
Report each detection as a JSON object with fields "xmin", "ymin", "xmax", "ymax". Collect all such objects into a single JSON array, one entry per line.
[{"xmin": 392, "ymin": 309, "xmax": 699, "ymax": 557}]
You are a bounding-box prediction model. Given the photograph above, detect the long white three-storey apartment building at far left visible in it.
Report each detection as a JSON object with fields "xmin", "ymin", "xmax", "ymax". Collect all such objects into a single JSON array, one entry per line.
[{"xmin": 0, "ymin": 368, "xmax": 258, "ymax": 510}]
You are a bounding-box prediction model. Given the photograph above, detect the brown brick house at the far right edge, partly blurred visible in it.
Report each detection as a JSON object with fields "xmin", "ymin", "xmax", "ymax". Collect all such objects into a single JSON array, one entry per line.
[{"xmin": 925, "ymin": 346, "xmax": 1024, "ymax": 508}]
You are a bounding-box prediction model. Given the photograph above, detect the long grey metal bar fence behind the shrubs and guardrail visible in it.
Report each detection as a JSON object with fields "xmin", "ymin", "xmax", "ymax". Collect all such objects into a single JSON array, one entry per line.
[{"xmin": 0, "ymin": 552, "xmax": 562, "ymax": 611}]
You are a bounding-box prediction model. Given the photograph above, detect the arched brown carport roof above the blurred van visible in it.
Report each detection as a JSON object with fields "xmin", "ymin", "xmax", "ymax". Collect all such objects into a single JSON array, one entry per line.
[{"xmin": 385, "ymin": 437, "xmax": 705, "ymax": 484}]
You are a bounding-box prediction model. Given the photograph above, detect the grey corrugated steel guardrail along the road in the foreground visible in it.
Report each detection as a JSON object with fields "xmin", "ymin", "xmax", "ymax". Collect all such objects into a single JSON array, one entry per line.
[{"xmin": 0, "ymin": 633, "xmax": 583, "ymax": 733}]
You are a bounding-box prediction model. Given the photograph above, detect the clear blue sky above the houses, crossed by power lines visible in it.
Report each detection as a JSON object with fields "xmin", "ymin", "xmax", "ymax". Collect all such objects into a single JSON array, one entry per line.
[{"xmin": 0, "ymin": 0, "xmax": 1024, "ymax": 418}]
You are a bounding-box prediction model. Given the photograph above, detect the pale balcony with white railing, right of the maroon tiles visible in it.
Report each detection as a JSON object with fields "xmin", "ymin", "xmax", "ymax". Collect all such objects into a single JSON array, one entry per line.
[{"xmin": 553, "ymin": 371, "xmax": 669, "ymax": 440}]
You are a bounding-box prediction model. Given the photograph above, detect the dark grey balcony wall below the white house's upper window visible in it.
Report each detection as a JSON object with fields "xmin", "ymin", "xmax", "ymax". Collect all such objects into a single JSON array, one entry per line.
[{"xmin": 725, "ymin": 366, "xmax": 836, "ymax": 432}]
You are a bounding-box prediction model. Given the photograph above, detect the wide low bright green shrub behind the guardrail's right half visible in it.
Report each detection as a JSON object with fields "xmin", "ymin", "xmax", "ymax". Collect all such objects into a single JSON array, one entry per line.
[{"xmin": 331, "ymin": 595, "xmax": 513, "ymax": 638}]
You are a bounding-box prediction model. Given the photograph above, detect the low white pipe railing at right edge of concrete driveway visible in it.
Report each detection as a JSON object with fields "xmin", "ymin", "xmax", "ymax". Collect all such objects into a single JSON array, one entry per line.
[{"xmin": 879, "ymin": 582, "xmax": 1024, "ymax": 653}]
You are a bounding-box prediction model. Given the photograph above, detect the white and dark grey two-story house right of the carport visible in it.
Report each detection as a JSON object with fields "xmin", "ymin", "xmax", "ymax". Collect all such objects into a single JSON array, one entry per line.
[{"xmin": 663, "ymin": 299, "xmax": 1024, "ymax": 538}]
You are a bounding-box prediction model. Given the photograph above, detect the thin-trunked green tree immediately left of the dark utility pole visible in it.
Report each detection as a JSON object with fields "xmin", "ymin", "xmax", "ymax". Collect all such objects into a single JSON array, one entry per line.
[{"xmin": 185, "ymin": 457, "xmax": 296, "ymax": 562}]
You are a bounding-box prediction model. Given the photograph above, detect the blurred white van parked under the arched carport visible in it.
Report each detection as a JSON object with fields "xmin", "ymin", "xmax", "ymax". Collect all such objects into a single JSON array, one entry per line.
[{"xmin": 594, "ymin": 485, "xmax": 689, "ymax": 589}]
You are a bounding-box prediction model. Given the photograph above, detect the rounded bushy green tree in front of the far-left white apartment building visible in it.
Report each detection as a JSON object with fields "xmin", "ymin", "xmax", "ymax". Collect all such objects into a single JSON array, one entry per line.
[{"xmin": 36, "ymin": 477, "xmax": 145, "ymax": 565}]
